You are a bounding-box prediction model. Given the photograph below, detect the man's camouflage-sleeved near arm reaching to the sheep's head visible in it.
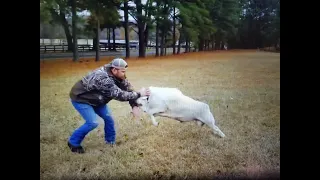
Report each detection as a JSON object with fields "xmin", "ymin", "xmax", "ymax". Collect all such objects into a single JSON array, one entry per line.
[{"xmin": 97, "ymin": 78, "xmax": 140, "ymax": 101}]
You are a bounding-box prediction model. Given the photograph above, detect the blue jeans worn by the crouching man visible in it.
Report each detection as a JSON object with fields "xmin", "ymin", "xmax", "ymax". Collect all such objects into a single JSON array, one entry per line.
[{"xmin": 69, "ymin": 101, "xmax": 116, "ymax": 147}]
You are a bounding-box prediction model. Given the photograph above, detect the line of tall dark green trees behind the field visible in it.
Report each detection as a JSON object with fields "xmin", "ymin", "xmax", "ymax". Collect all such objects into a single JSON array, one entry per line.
[{"xmin": 40, "ymin": 0, "xmax": 280, "ymax": 61}]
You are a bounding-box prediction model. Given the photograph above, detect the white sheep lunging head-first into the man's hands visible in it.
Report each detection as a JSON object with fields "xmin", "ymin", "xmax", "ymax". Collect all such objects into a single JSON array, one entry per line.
[{"xmin": 136, "ymin": 86, "xmax": 225, "ymax": 137}]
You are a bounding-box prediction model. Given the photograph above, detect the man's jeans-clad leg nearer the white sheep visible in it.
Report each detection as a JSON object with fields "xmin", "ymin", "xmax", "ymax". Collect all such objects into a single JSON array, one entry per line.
[{"xmin": 94, "ymin": 105, "xmax": 116, "ymax": 144}]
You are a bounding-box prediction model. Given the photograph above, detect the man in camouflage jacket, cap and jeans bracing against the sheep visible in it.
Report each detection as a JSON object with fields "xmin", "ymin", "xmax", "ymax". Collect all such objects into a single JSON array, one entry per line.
[{"xmin": 68, "ymin": 58, "xmax": 150, "ymax": 153}]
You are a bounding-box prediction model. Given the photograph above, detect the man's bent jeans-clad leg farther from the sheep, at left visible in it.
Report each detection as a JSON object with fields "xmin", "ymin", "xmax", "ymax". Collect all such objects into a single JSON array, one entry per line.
[{"xmin": 69, "ymin": 101, "xmax": 99, "ymax": 152}]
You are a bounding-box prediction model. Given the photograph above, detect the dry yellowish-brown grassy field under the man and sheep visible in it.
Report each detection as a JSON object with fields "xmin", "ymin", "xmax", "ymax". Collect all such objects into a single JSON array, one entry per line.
[{"xmin": 40, "ymin": 51, "xmax": 280, "ymax": 179}]
